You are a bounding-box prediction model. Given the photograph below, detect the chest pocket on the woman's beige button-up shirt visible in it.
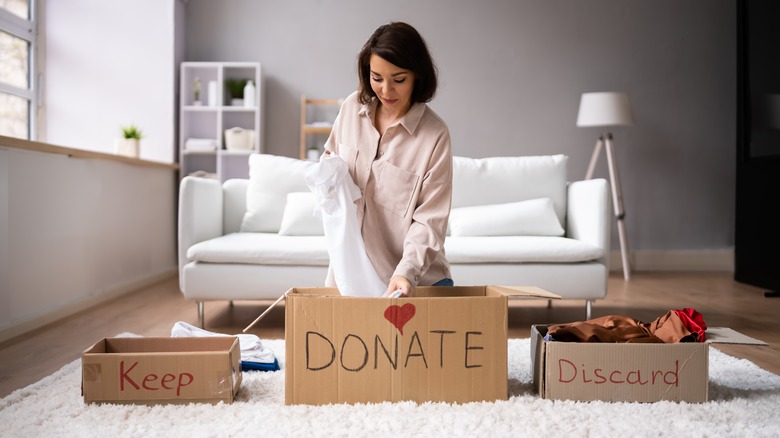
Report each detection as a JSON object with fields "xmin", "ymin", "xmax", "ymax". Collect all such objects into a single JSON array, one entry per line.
[{"xmin": 374, "ymin": 161, "xmax": 420, "ymax": 217}]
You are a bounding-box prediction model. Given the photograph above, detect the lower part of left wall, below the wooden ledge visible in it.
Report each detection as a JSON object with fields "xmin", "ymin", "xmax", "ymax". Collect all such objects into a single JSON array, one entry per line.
[{"xmin": 0, "ymin": 143, "xmax": 176, "ymax": 340}]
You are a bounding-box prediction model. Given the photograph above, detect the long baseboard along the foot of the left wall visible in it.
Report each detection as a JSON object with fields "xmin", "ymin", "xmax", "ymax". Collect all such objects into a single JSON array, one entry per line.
[{"xmin": 0, "ymin": 267, "xmax": 178, "ymax": 342}]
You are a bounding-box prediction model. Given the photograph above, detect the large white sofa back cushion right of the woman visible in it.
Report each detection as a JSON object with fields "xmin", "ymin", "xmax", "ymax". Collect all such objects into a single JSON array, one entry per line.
[{"xmin": 452, "ymin": 155, "xmax": 568, "ymax": 224}]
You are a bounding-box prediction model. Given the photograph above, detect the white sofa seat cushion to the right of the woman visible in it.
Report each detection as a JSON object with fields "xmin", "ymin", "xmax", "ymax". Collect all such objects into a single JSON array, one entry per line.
[{"xmin": 444, "ymin": 236, "xmax": 604, "ymax": 264}]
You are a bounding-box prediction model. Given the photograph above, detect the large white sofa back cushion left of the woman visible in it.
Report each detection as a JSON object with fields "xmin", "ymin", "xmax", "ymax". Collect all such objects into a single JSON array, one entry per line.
[{"xmin": 241, "ymin": 154, "xmax": 315, "ymax": 233}]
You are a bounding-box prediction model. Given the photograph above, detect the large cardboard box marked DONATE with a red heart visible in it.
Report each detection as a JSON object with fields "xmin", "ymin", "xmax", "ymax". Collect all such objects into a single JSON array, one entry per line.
[{"xmin": 285, "ymin": 286, "xmax": 560, "ymax": 405}]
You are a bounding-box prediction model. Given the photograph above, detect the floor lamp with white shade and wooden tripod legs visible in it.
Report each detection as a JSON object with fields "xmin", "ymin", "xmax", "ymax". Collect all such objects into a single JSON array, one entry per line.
[{"xmin": 577, "ymin": 92, "xmax": 634, "ymax": 280}]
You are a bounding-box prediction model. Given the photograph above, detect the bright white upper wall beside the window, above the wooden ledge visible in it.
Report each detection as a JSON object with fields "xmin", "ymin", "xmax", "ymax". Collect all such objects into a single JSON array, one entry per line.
[{"xmin": 41, "ymin": 0, "xmax": 179, "ymax": 163}]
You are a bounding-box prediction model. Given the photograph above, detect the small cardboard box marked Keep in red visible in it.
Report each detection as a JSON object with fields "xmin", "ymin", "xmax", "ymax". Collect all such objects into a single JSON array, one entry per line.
[{"xmin": 81, "ymin": 336, "xmax": 241, "ymax": 404}]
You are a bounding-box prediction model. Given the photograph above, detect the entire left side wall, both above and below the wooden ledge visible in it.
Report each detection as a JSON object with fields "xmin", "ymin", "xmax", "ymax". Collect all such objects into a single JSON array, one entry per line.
[{"xmin": 0, "ymin": 0, "xmax": 184, "ymax": 341}]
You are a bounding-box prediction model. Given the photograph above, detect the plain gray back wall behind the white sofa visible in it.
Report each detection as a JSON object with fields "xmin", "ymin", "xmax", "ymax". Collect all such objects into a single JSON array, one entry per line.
[{"xmin": 185, "ymin": 0, "xmax": 736, "ymax": 250}]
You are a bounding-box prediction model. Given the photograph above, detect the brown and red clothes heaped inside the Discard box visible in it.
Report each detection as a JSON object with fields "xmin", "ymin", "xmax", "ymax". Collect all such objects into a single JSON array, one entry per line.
[{"xmin": 545, "ymin": 308, "xmax": 707, "ymax": 343}]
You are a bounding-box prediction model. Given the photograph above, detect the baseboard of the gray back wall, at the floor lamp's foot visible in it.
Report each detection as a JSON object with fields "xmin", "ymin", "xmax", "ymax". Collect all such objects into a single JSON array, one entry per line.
[{"xmin": 609, "ymin": 248, "xmax": 734, "ymax": 272}]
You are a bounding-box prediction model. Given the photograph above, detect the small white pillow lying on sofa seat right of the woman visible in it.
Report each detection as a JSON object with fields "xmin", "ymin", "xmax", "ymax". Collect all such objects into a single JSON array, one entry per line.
[{"xmin": 449, "ymin": 198, "xmax": 564, "ymax": 236}]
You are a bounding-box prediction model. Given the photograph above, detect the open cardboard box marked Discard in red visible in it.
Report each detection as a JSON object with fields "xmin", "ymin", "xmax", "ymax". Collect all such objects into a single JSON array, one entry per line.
[{"xmin": 531, "ymin": 325, "xmax": 766, "ymax": 403}]
